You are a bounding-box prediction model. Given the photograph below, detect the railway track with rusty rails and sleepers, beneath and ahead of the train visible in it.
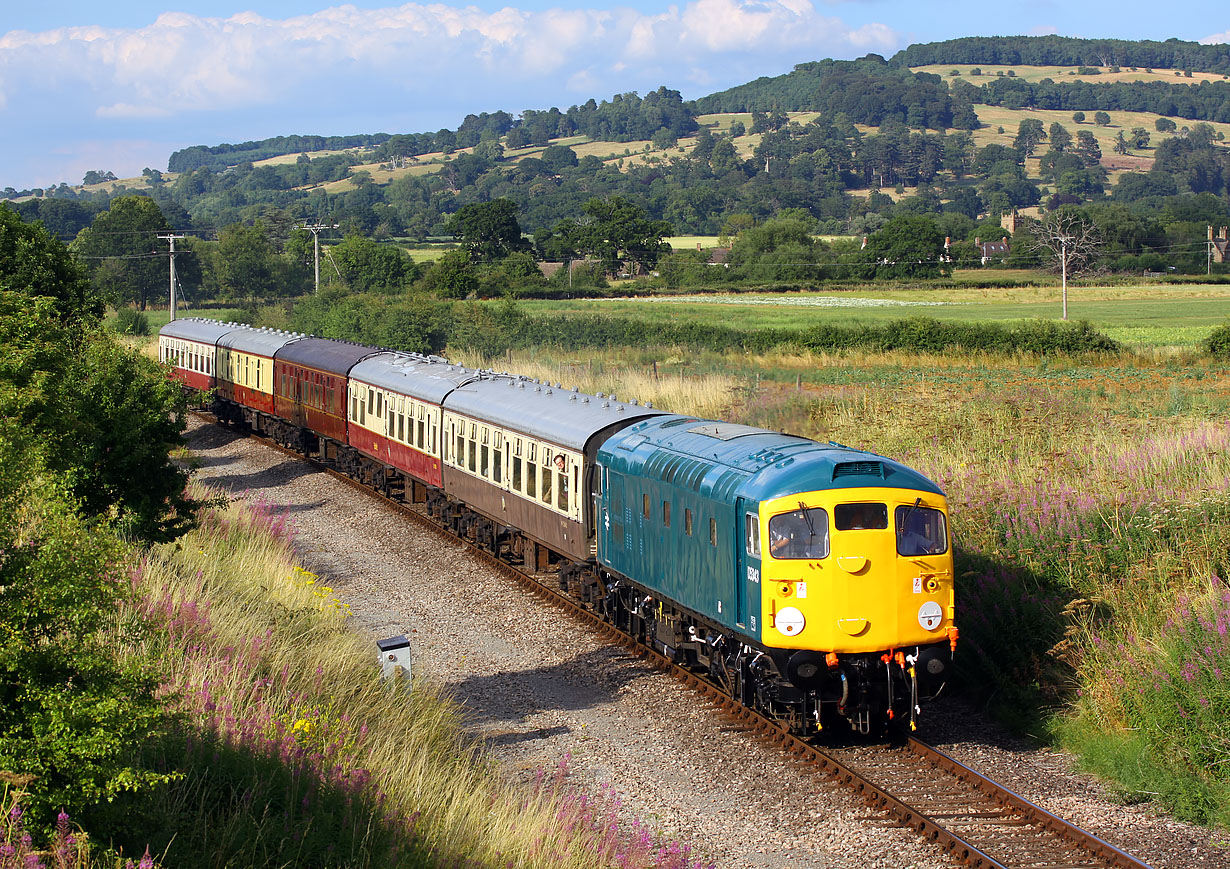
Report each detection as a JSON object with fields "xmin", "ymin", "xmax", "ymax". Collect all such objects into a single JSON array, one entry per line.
[{"xmin": 196, "ymin": 412, "xmax": 1149, "ymax": 869}]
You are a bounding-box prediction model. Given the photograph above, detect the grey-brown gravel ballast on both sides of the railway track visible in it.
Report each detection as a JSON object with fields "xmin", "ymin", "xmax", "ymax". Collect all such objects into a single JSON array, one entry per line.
[{"xmin": 189, "ymin": 420, "xmax": 1230, "ymax": 869}]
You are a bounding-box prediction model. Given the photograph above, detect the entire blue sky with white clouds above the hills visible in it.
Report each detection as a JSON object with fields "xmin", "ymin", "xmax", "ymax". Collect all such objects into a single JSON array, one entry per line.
[{"xmin": 0, "ymin": 0, "xmax": 1230, "ymax": 189}]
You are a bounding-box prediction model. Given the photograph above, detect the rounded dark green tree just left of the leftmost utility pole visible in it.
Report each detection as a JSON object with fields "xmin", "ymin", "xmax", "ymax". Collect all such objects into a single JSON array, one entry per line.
[{"xmin": 71, "ymin": 197, "xmax": 177, "ymax": 311}]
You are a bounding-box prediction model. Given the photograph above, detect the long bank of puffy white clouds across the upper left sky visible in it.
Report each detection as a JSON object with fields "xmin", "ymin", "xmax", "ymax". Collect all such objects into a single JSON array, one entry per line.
[{"xmin": 0, "ymin": 0, "xmax": 897, "ymax": 117}]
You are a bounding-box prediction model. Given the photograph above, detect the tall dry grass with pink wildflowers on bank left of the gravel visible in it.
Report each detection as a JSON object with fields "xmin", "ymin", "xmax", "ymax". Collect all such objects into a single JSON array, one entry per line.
[{"xmin": 100, "ymin": 493, "xmax": 718, "ymax": 867}]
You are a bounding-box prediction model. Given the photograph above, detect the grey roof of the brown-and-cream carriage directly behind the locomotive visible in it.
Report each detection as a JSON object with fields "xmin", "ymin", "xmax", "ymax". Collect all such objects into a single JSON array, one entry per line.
[{"xmin": 444, "ymin": 374, "xmax": 665, "ymax": 450}]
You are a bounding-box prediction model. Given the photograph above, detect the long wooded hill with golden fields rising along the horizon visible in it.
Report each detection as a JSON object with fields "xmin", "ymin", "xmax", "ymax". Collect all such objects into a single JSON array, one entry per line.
[{"xmin": 5, "ymin": 37, "xmax": 1230, "ymax": 276}]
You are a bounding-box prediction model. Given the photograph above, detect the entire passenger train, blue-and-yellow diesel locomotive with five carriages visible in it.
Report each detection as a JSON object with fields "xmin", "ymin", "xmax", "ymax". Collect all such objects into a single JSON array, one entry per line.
[{"xmin": 160, "ymin": 320, "xmax": 957, "ymax": 734}]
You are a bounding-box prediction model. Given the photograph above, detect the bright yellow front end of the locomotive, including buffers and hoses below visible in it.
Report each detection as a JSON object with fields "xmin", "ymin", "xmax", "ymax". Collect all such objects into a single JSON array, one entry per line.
[{"xmin": 759, "ymin": 487, "xmax": 957, "ymax": 733}]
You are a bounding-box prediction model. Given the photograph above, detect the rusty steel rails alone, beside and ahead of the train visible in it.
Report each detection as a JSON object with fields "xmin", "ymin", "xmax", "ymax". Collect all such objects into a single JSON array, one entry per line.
[{"xmin": 192, "ymin": 411, "xmax": 1150, "ymax": 869}]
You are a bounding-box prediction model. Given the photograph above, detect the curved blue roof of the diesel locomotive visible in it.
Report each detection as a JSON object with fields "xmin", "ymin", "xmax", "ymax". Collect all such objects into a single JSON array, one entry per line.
[{"xmin": 599, "ymin": 415, "xmax": 943, "ymax": 500}]
